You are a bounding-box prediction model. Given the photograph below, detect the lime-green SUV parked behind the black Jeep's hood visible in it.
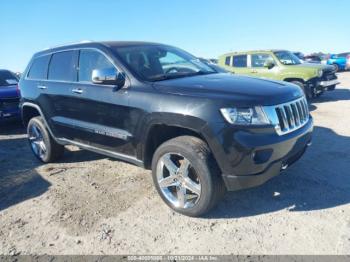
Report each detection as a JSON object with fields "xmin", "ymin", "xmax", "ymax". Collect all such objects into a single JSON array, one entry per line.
[{"xmin": 218, "ymin": 50, "xmax": 339, "ymax": 98}]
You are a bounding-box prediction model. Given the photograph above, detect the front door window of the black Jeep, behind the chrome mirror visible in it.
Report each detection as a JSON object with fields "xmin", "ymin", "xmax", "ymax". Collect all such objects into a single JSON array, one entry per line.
[{"xmin": 79, "ymin": 49, "xmax": 115, "ymax": 82}]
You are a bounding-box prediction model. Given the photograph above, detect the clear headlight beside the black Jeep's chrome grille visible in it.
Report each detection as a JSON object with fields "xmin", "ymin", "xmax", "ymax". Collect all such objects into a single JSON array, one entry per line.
[{"xmin": 220, "ymin": 106, "xmax": 270, "ymax": 125}]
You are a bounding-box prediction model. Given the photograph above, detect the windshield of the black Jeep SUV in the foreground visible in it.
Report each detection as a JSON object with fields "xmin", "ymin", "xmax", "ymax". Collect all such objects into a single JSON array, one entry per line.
[{"xmin": 115, "ymin": 45, "xmax": 216, "ymax": 81}]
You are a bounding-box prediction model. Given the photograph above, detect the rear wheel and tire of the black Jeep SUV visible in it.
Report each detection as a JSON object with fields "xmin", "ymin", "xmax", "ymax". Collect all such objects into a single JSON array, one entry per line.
[{"xmin": 27, "ymin": 116, "xmax": 64, "ymax": 163}]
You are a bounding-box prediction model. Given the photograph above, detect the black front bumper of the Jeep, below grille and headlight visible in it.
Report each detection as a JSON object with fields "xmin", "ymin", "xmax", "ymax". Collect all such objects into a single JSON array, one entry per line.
[{"xmin": 204, "ymin": 117, "xmax": 313, "ymax": 191}]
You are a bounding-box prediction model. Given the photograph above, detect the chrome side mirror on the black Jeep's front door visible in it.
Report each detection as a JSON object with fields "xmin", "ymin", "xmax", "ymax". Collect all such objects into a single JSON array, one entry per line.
[{"xmin": 92, "ymin": 68, "xmax": 125, "ymax": 89}]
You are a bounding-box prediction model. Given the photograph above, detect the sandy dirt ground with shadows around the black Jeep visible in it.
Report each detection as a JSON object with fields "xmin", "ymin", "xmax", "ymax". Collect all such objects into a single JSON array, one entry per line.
[{"xmin": 0, "ymin": 73, "xmax": 350, "ymax": 255}]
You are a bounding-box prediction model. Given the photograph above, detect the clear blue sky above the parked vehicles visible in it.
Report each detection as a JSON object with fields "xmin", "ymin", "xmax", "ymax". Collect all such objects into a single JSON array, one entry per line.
[{"xmin": 0, "ymin": 0, "xmax": 350, "ymax": 71}]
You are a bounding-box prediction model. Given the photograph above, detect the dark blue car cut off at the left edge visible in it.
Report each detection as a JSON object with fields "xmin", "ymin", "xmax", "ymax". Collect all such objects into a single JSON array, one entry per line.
[{"xmin": 0, "ymin": 69, "xmax": 20, "ymax": 122}]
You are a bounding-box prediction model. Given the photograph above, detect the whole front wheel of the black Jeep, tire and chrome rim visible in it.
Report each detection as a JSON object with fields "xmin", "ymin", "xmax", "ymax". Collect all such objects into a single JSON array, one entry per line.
[{"xmin": 152, "ymin": 136, "xmax": 226, "ymax": 217}]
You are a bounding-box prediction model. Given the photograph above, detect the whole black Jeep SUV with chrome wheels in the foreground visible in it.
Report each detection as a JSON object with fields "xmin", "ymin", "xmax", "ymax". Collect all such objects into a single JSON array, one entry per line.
[{"xmin": 20, "ymin": 42, "xmax": 313, "ymax": 216}]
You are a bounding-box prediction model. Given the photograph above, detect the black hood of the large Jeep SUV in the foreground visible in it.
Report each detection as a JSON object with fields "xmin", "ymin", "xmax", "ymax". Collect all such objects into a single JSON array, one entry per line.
[{"xmin": 153, "ymin": 74, "xmax": 303, "ymax": 105}]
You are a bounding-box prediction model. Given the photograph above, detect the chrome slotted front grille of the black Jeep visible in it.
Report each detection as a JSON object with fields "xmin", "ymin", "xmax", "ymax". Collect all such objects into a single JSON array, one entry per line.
[{"xmin": 264, "ymin": 97, "xmax": 309, "ymax": 135}]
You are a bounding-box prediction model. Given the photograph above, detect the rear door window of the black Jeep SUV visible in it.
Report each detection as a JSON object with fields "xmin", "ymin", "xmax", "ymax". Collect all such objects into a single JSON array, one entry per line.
[{"xmin": 49, "ymin": 51, "xmax": 78, "ymax": 82}]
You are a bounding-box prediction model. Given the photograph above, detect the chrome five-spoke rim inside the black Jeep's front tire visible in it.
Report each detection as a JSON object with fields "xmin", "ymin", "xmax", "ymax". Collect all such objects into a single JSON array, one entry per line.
[{"xmin": 156, "ymin": 153, "xmax": 201, "ymax": 208}]
